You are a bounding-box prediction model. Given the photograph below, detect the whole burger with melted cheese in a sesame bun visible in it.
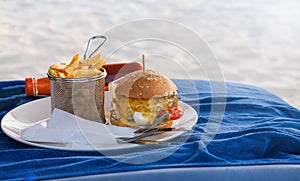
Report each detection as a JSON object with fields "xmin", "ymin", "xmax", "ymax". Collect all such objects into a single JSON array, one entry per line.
[{"xmin": 110, "ymin": 70, "xmax": 183, "ymax": 128}]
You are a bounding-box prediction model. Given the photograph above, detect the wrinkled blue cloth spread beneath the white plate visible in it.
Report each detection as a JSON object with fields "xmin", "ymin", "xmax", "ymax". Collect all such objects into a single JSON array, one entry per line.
[{"xmin": 0, "ymin": 80, "xmax": 300, "ymax": 180}]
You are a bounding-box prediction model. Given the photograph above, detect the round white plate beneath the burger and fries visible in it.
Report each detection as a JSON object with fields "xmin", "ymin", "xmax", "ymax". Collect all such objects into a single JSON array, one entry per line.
[{"xmin": 1, "ymin": 96, "xmax": 198, "ymax": 151}]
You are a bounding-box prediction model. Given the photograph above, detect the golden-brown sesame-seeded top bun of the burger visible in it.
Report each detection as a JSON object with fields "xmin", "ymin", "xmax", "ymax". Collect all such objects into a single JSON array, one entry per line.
[{"xmin": 115, "ymin": 70, "xmax": 177, "ymax": 99}]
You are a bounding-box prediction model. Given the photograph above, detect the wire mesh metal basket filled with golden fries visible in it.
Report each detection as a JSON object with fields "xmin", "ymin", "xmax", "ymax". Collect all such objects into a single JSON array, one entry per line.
[{"xmin": 47, "ymin": 54, "xmax": 107, "ymax": 123}]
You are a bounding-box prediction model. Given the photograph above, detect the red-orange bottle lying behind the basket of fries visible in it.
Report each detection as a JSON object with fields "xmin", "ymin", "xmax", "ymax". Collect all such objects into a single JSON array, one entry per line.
[{"xmin": 25, "ymin": 62, "xmax": 143, "ymax": 96}]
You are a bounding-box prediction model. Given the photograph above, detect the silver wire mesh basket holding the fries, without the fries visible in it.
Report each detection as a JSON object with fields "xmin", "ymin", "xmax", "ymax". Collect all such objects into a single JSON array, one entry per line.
[{"xmin": 48, "ymin": 68, "xmax": 107, "ymax": 123}]
